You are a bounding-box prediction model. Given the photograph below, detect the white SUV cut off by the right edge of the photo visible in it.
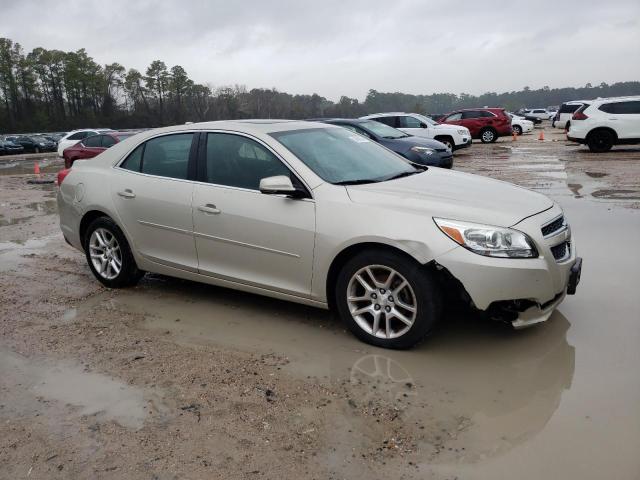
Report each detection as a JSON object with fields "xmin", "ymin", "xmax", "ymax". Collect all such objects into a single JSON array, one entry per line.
[{"xmin": 567, "ymin": 96, "xmax": 640, "ymax": 152}]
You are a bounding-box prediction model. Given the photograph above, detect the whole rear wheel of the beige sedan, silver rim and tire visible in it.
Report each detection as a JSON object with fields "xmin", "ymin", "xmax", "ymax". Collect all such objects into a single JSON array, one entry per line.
[{"xmin": 84, "ymin": 217, "xmax": 144, "ymax": 288}]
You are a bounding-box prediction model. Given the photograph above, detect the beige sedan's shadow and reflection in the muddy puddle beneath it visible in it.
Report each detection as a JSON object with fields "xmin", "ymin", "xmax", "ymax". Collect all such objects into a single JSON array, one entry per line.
[{"xmin": 70, "ymin": 276, "xmax": 574, "ymax": 464}]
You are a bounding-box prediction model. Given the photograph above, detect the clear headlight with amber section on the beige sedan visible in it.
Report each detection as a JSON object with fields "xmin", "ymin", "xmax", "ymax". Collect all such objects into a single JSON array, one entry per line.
[{"xmin": 433, "ymin": 217, "xmax": 538, "ymax": 258}]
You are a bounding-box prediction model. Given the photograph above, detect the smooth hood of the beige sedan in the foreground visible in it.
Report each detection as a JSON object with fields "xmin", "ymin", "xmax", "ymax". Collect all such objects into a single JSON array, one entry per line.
[{"xmin": 347, "ymin": 168, "xmax": 553, "ymax": 227}]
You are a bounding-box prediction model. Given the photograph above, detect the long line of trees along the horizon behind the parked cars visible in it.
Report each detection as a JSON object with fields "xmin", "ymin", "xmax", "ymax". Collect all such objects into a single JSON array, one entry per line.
[{"xmin": 0, "ymin": 38, "xmax": 640, "ymax": 133}]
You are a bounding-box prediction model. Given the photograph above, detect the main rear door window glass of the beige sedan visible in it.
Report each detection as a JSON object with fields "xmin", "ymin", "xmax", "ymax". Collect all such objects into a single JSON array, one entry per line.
[{"xmin": 141, "ymin": 133, "xmax": 193, "ymax": 180}]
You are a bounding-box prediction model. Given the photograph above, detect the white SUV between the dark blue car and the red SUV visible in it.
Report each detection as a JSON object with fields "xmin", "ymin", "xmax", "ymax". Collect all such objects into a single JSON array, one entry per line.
[{"xmin": 360, "ymin": 112, "xmax": 471, "ymax": 151}]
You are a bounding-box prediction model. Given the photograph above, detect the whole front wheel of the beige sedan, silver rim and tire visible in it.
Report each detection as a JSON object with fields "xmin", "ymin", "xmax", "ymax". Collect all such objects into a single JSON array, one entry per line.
[{"xmin": 335, "ymin": 249, "xmax": 442, "ymax": 349}]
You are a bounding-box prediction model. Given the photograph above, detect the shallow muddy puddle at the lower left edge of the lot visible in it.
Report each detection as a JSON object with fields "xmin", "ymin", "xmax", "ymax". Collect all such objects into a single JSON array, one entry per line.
[{"xmin": 0, "ymin": 349, "xmax": 166, "ymax": 429}]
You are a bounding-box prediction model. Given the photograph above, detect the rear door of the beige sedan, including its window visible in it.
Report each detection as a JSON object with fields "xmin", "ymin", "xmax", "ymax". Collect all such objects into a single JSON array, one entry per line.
[{"xmin": 111, "ymin": 132, "xmax": 198, "ymax": 272}]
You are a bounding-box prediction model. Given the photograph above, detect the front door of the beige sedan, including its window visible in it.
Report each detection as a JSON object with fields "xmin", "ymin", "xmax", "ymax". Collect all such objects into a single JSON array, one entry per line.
[{"xmin": 193, "ymin": 133, "xmax": 315, "ymax": 297}]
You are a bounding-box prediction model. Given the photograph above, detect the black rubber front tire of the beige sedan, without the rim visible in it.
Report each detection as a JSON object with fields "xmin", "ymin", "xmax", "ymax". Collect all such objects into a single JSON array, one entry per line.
[{"xmin": 334, "ymin": 250, "xmax": 442, "ymax": 349}]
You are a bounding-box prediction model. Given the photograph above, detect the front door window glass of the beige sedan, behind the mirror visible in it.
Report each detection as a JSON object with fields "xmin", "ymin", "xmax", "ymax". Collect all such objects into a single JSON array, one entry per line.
[{"xmin": 206, "ymin": 133, "xmax": 291, "ymax": 190}]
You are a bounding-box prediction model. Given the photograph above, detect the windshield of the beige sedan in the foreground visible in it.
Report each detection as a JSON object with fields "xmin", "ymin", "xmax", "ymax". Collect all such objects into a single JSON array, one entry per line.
[{"xmin": 271, "ymin": 126, "xmax": 419, "ymax": 184}]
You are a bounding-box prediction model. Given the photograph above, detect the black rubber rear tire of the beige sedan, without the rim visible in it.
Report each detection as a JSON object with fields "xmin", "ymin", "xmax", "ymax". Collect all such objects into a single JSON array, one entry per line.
[{"xmin": 82, "ymin": 217, "xmax": 144, "ymax": 288}]
